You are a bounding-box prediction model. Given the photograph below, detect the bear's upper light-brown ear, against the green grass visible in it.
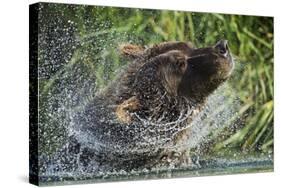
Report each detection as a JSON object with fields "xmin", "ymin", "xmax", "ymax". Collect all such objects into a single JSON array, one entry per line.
[{"xmin": 119, "ymin": 44, "xmax": 144, "ymax": 59}]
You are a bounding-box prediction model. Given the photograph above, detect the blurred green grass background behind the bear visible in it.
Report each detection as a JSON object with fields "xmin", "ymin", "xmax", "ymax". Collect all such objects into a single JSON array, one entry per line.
[{"xmin": 39, "ymin": 4, "xmax": 274, "ymax": 156}]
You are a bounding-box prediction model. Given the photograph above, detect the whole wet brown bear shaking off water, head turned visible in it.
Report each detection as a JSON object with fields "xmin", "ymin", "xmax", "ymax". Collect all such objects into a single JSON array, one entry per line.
[{"xmin": 74, "ymin": 40, "xmax": 234, "ymax": 170}]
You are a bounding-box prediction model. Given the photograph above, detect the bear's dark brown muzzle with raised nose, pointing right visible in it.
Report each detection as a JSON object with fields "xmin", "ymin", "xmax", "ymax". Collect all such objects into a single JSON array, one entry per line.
[{"xmin": 178, "ymin": 40, "xmax": 234, "ymax": 100}]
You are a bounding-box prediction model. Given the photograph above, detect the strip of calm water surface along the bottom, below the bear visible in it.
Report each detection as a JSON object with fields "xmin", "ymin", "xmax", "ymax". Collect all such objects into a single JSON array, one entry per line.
[{"xmin": 40, "ymin": 156, "xmax": 273, "ymax": 186}]
